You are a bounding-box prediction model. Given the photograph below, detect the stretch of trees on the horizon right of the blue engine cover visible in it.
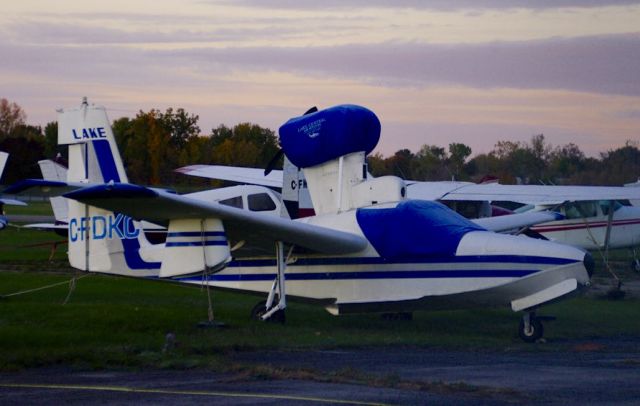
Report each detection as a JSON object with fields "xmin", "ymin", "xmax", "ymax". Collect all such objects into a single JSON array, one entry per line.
[{"xmin": 368, "ymin": 134, "xmax": 640, "ymax": 186}]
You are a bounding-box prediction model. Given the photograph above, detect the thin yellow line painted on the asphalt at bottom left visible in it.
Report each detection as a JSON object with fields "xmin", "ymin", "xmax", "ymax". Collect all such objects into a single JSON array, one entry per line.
[{"xmin": 0, "ymin": 383, "xmax": 385, "ymax": 406}]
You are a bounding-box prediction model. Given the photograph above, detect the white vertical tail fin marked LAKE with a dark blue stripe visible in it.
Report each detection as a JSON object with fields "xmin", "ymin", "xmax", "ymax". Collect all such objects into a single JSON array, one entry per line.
[{"xmin": 55, "ymin": 99, "xmax": 160, "ymax": 276}]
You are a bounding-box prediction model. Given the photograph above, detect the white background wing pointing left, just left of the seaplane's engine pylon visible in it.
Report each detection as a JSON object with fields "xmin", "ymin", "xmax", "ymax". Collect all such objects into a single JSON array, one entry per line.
[{"xmin": 175, "ymin": 165, "xmax": 282, "ymax": 188}]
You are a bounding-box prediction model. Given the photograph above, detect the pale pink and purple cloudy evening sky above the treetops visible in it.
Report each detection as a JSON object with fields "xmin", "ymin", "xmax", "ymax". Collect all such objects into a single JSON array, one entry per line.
[{"xmin": 0, "ymin": 0, "xmax": 640, "ymax": 156}]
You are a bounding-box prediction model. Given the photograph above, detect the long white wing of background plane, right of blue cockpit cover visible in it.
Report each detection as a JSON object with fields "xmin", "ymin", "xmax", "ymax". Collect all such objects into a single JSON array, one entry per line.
[{"xmin": 407, "ymin": 182, "xmax": 640, "ymax": 205}]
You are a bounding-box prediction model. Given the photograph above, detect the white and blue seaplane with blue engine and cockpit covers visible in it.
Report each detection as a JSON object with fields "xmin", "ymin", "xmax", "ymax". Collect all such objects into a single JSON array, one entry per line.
[{"xmin": 7, "ymin": 102, "xmax": 594, "ymax": 342}]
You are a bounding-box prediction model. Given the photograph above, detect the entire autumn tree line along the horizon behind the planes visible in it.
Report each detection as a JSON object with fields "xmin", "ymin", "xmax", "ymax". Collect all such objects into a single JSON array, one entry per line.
[{"xmin": 0, "ymin": 98, "xmax": 640, "ymax": 185}]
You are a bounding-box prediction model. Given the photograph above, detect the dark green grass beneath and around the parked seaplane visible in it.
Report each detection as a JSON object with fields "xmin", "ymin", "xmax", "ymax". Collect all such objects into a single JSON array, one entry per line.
[{"xmin": 0, "ymin": 228, "xmax": 640, "ymax": 371}]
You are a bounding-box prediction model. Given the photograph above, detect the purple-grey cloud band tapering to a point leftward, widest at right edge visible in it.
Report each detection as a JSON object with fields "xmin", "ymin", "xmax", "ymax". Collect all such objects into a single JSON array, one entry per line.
[{"xmin": 171, "ymin": 34, "xmax": 640, "ymax": 95}]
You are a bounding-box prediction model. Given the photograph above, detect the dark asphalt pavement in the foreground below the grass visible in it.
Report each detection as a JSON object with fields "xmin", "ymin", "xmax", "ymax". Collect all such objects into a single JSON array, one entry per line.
[{"xmin": 0, "ymin": 337, "xmax": 640, "ymax": 405}]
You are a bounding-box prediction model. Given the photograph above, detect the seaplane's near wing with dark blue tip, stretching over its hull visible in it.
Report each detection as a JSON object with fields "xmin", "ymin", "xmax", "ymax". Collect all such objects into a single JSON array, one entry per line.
[{"xmin": 64, "ymin": 183, "xmax": 367, "ymax": 254}]
